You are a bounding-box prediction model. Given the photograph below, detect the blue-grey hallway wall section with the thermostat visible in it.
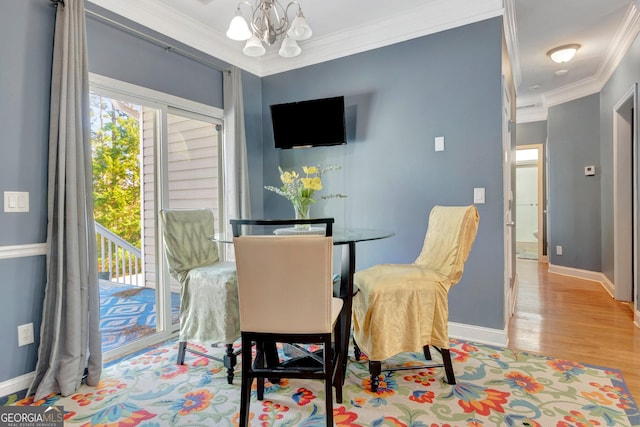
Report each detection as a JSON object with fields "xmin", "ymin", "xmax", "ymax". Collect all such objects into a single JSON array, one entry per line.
[{"xmin": 547, "ymin": 94, "xmax": 601, "ymax": 271}]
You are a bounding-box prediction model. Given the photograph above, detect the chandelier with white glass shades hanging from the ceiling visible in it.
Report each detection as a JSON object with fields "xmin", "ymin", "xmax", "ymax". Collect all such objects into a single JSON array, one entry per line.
[{"xmin": 227, "ymin": 0, "xmax": 311, "ymax": 58}]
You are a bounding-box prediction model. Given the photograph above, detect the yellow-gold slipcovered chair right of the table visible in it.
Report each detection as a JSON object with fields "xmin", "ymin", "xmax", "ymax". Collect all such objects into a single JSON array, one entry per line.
[{"xmin": 353, "ymin": 206, "xmax": 479, "ymax": 392}]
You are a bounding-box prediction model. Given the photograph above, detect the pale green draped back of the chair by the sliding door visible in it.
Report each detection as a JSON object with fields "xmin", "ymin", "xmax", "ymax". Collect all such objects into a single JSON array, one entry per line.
[{"xmin": 160, "ymin": 209, "xmax": 219, "ymax": 283}]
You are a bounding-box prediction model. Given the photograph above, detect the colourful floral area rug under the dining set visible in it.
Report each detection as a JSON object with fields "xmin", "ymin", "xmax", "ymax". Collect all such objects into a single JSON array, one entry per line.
[{"xmin": 14, "ymin": 340, "xmax": 640, "ymax": 427}]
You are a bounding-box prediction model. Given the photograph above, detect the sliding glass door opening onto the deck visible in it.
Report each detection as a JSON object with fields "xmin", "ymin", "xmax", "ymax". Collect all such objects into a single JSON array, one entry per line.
[{"xmin": 91, "ymin": 77, "xmax": 223, "ymax": 361}]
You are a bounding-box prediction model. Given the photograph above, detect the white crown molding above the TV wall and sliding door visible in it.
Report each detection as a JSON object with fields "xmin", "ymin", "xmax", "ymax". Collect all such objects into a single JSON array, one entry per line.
[{"xmin": 89, "ymin": 0, "xmax": 504, "ymax": 77}]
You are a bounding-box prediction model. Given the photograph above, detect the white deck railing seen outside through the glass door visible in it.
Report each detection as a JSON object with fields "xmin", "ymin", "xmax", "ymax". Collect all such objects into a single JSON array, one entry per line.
[{"xmin": 96, "ymin": 222, "xmax": 144, "ymax": 286}]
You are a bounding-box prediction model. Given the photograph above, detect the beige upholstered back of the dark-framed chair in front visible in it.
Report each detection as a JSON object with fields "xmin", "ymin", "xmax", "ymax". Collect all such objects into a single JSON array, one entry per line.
[{"xmin": 231, "ymin": 218, "xmax": 333, "ymax": 334}]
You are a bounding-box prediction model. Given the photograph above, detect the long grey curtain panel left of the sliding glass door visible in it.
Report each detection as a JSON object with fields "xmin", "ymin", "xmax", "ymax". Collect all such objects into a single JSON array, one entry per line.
[{"xmin": 28, "ymin": 0, "xmax": 102, "ymax": 400}]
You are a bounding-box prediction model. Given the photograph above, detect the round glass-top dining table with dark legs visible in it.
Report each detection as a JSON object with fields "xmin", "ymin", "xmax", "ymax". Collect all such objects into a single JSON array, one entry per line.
[{"xmin": 213, "ymin": 227, "xmax": 395, "ymax": 372}]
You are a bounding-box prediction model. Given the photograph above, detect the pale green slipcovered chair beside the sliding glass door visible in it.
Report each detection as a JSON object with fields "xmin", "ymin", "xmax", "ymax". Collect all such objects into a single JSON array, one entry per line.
[{"xmin": 160, "ymin": 209, "xmax": 240, "ymax": 384}]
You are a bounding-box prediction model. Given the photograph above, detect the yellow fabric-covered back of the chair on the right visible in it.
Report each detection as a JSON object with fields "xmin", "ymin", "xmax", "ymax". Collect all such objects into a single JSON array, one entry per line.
[{"xmin": 414, "ymin": 205, "xmax": 480, "ymax": 285}]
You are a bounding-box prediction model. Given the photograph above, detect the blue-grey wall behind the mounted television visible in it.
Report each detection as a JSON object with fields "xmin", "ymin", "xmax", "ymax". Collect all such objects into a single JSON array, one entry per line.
[{"xmin": 262, "ymin": 18, "xmax": 505, "ymax": 330}]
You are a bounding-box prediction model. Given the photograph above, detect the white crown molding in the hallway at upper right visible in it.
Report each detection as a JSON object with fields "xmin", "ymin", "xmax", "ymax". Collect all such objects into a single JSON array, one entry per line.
[{"xmin": 517, "ymin": 1, "xmax": 640, "ymax": 123}]
